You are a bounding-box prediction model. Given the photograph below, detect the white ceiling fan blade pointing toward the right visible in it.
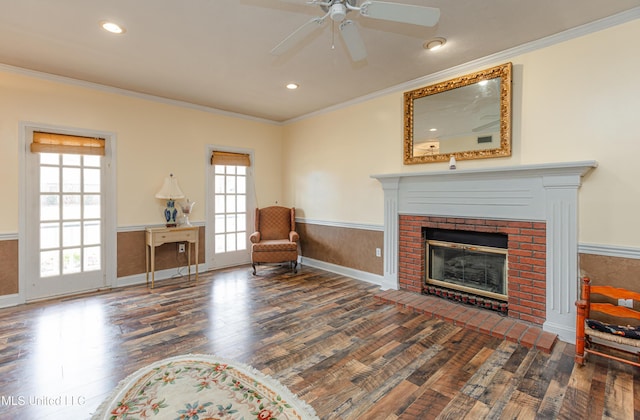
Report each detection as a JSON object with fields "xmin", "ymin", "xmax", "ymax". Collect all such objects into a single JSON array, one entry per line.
[{"xmin": 360, "ymin": 1, "xmax": 440, "ymax": 26}]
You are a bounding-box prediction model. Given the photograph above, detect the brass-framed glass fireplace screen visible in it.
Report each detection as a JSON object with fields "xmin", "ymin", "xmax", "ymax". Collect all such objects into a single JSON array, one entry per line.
[{"xmin": 427, "ymin": 240, "xmax": 507, "ymax": 300}]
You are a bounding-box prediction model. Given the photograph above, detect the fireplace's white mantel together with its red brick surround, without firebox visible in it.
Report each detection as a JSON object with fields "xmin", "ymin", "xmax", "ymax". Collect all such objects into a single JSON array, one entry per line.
[{"xmin": 372, "ymin": 161, "xmax": 597, "ymax": 342}]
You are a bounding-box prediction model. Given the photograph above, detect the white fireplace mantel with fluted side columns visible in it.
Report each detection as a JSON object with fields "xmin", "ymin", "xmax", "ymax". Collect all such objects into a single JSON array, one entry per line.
[{"xmin": 371, "ymin": 160, "xmax": 598, "ymax": 342}]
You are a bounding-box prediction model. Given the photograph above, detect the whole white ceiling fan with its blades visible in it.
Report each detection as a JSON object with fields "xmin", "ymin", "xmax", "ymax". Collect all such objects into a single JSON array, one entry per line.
[{"xmin": 271, "ymin": 0, "xmax": 440, "ymax": 61}]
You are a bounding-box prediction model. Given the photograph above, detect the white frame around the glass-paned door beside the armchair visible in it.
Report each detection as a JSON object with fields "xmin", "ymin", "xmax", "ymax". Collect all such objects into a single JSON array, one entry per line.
[{"xmin": 205, "ymin": 144, "xmax": 258, "ymax": 270}]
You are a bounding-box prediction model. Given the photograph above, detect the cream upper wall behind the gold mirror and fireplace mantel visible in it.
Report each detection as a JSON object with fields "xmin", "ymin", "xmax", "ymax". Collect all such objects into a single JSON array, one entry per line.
[{"xmin": 284, "ymin": 20, "xmax": 640, "ymax": 247}]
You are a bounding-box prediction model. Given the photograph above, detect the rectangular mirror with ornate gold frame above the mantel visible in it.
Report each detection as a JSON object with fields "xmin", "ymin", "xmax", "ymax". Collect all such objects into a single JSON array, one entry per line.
[{"xmin": 404, "ymin": 63, "xmax": 511, "ymax": 165}]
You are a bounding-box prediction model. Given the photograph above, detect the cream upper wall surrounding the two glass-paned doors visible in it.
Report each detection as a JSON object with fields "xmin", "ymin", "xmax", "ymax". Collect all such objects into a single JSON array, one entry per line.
[{"xmin": 0, "ymin": 69, "xmax": 283, "ymax": 234}]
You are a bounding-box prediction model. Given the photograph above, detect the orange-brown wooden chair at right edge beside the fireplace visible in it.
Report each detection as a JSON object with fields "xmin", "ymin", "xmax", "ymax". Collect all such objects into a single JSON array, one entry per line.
[{"xmin": 575, "ymin": 277, "xmax": 640, "ymax": 367}]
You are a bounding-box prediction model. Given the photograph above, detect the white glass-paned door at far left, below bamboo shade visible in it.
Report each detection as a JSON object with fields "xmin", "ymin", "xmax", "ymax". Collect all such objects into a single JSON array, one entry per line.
[{"xmin": 26, "ymin": 136, "xmax": 105, "ymax": 300}]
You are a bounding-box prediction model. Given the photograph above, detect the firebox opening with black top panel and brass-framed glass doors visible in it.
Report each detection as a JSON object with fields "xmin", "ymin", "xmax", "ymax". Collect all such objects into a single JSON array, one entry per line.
[{"xmin": 424, "ymin": 229, "xmax": 508, "ymax": 302}]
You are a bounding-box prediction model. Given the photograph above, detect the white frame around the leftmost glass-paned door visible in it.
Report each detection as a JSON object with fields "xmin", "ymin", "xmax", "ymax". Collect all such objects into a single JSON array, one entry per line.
[{"xmin": 18, "ymin": 121, "xmax": 117, "ymax": 303}]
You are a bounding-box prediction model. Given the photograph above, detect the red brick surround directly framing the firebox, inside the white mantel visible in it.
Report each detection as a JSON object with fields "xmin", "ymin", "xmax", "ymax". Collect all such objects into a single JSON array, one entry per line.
[{"xmin": 398, "ymin": 215, "xmax": 547, "ymax": 325}]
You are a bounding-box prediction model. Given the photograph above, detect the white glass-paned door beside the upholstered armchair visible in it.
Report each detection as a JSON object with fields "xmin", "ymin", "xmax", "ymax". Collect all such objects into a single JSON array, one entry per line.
[{"xmin": 207, "ymin": 159, "xmax": 255, "ymax": 268}]
